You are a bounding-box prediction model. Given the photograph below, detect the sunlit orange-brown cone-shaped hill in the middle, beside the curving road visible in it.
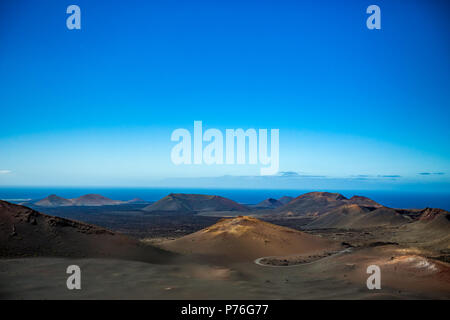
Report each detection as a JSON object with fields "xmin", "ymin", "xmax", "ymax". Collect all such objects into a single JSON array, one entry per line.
[{"xmin": 161, "ymin": 216, "xmax": 338, "ymax": 261}]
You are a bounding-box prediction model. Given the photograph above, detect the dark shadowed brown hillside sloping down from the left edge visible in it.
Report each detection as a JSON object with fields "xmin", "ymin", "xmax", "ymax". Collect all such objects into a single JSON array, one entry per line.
[{"xmin": 0, "ymin": 200, "xmax": 171, "ymax": 262}]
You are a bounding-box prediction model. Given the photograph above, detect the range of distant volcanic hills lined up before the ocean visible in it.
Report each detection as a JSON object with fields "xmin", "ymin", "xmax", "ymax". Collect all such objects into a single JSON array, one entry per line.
[{"xmin": 21, "ymin": 192, "xmax": 446, "ymax": 229}]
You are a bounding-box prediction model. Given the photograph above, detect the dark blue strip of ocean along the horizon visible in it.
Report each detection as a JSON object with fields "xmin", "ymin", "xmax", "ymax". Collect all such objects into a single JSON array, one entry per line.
[{"xmin": 0, "ymin": 187, "xmax": 450, "ymax": 210}]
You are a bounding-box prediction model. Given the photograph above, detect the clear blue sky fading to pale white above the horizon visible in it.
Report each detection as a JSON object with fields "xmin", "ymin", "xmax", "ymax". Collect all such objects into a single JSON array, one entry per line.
[{"xmin": 0, "ymin": 0, "xmax": 450, "ymax": 191}]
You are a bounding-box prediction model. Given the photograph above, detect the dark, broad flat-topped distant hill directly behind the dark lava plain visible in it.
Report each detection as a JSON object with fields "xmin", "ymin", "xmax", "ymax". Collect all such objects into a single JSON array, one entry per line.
[{"xmin": 142, "ymin": 193, "xmax": 249, "ymax": 213}]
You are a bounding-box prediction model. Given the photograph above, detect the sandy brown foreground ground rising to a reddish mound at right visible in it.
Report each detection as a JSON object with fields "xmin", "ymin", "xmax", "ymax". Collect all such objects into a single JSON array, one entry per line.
[{"xmin": 0, "ymin": 246, "xmax": 450, "ymax": 299}]
